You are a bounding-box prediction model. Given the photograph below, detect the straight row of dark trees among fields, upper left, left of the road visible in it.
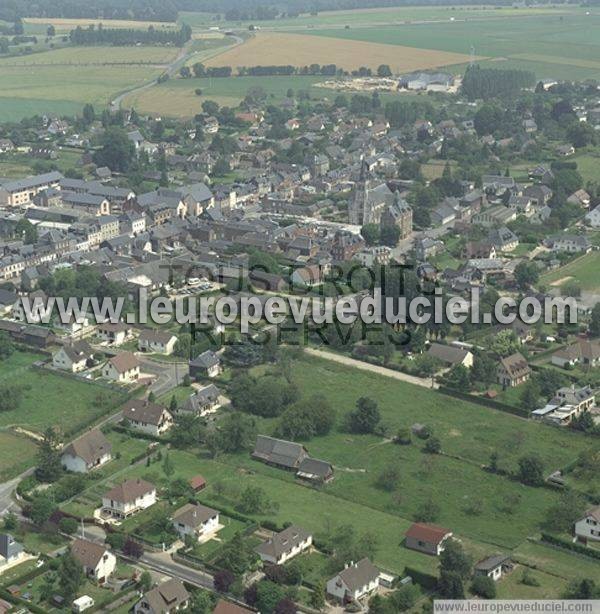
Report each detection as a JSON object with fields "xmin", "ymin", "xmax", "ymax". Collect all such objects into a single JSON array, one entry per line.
[{"xmin": 69, "ymin": 24, "xmax": 192, "ymax": 47}]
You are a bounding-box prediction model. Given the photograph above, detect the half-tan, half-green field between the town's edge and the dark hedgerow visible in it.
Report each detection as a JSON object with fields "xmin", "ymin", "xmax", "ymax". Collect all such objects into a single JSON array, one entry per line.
[{"xmin": 124, "ymin": 77, "xmax": 334, "ymax": 117}]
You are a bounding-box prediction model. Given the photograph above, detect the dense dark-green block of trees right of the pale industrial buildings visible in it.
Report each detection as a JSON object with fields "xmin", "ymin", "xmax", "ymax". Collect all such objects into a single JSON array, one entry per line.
[{"xmin": 462, "ymin": 65, "xmax": 535, "ymax": 100}]
